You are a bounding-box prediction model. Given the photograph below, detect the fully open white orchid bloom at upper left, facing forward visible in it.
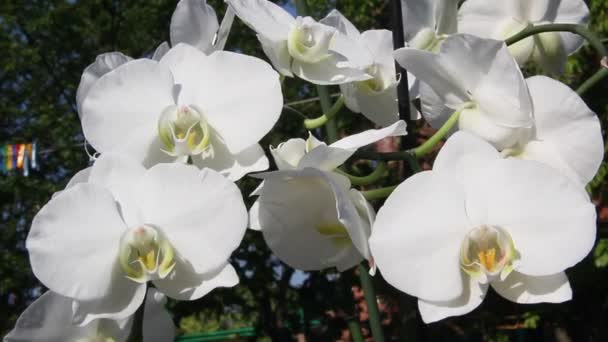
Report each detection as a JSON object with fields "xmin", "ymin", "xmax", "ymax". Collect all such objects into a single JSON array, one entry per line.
[{"xmin": 81, "ymin": 44, "xmax": 283, "ymax": 180}]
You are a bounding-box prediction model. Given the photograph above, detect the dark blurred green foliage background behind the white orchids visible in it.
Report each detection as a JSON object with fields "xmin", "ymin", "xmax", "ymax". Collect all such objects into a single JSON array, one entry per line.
[{"xmin": 0, "ymin": 0, "xmax": 608, "ymax": 341}]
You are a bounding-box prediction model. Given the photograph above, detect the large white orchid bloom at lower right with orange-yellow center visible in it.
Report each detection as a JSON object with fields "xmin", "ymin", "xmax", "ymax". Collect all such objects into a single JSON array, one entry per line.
[{"xmin": 370, "ymin": 132, "xmax": 596, "ymax": 323}]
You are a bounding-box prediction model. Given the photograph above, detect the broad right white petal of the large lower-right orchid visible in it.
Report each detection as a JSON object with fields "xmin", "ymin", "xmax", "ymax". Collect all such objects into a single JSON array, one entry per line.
[{"xmin": 467, "ymin": 158, "xmax": 596, "ymax": 276}]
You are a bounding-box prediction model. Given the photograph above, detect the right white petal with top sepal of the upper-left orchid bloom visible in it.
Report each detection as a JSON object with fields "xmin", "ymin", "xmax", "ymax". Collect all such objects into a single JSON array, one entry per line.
[{"xmin": 160, "ymin": 44, "xmax": 283, "ymax": 154}]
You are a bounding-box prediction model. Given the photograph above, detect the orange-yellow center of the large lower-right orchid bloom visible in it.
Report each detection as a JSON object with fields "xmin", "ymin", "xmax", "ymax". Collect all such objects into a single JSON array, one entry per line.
[{"xmin": 460, "ymin": 225, "xmax": 518, "ymax": 283}]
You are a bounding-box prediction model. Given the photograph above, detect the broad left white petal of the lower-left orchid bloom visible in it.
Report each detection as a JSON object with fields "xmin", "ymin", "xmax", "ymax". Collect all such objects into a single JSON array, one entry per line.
[{"xmin": 26, "ymin": 183, "xmax": 126, "ymax": 300}]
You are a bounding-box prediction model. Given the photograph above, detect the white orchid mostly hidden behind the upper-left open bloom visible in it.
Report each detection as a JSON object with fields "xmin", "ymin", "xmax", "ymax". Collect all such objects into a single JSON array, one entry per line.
[{"xmin": 76, "ymin": 0, "xmax": 228, "ymax": 115}]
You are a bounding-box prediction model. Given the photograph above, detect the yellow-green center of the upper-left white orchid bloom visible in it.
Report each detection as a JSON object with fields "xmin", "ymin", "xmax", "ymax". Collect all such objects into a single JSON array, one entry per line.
[{"xmin": 158, "ymin": 106, "xmax": 211, "ymax": 157}]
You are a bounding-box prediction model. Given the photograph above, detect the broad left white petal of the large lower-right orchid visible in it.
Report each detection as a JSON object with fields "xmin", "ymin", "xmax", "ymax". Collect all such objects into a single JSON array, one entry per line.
[{"xmin": 370, "ymin": 171, "xmax": 471, "ymax": 301}]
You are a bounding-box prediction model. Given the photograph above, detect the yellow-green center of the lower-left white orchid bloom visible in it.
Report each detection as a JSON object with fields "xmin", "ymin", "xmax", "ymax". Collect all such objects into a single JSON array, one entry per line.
[{"xmin": 119, "ymin": 225, "xmax": 175, "ymax": 283}]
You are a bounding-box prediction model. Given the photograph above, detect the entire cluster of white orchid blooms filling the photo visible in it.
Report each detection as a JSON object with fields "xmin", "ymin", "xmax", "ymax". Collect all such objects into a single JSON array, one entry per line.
[{"xmin": 5, "ymin": 0, "xmax": 604, "ymax": 341}]
